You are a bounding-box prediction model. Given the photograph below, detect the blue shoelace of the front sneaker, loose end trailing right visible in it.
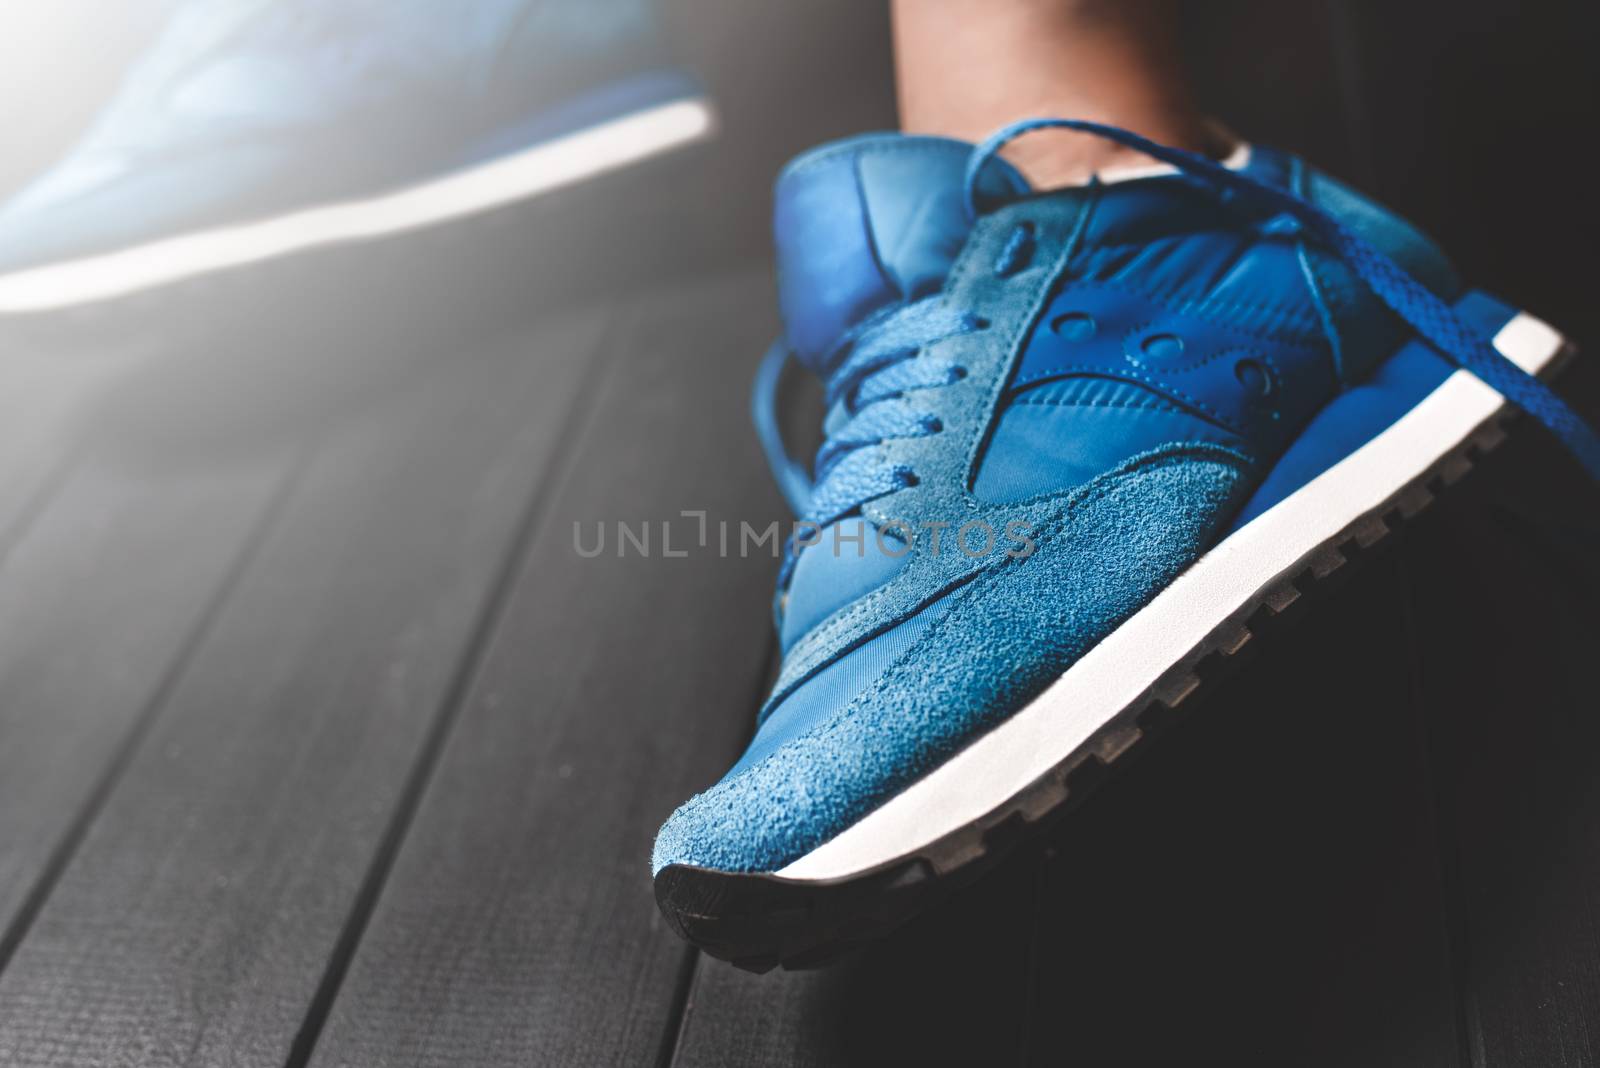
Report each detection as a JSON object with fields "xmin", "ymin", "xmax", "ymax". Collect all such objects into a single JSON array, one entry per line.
[{"xmin": 754, "ymin": 118, "xmax": 1600, "ymax": 534}]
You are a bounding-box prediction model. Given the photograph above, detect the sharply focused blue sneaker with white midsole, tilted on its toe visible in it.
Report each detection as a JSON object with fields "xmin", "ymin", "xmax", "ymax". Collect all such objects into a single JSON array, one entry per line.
[{"xmin": 653, "ymin": 120, "xmax": 1600, "ymax": 969}]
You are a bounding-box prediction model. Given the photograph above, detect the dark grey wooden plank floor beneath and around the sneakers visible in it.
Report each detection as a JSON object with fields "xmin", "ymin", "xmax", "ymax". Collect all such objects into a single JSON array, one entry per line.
[{"xmin": 0, "ymin": 0, "xmax": 1600, "ymax": 1068}]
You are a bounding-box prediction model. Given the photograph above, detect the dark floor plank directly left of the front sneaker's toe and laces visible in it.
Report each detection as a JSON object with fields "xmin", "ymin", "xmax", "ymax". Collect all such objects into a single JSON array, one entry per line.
[{"xmin": 302, "ymin": 275, "xmax": 781, "ymax": 1066}]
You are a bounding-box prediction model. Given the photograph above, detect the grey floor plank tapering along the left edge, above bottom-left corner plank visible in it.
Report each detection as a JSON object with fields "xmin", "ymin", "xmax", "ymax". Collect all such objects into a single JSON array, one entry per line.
[{"xmin": 0, "ymin": 452, "xmax": 288, "ymax": 967}]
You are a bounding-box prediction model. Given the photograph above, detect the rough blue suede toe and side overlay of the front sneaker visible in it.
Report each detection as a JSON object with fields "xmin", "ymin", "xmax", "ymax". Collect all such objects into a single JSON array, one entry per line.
[{"xmin": 653, "ymin": 452, "xmax": 1248, "ymax": 871}]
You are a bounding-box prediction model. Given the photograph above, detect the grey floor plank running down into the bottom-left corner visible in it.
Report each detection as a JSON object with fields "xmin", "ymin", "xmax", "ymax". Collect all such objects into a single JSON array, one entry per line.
[{"xmin": 0, "ymin": 308, "xmax": 602, "ymax": 1068}]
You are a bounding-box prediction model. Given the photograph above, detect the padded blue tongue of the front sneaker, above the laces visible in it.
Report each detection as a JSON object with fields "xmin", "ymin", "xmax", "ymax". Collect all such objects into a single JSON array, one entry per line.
[{"xmin": 773, "ymin": 134, "xmax": 1027, "ymax": 373}]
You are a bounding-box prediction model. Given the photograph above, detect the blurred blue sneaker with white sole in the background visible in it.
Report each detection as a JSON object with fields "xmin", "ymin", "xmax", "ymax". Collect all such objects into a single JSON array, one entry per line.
[{"xmin": 0, "ymin": 0, "xmax": 709, "ymax": 312}]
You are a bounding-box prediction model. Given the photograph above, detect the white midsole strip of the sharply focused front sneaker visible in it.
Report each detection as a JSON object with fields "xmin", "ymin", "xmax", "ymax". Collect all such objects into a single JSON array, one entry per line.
[{"xmin": 778, "ymin": 313, "xmax": 1563, "ymax": 879}]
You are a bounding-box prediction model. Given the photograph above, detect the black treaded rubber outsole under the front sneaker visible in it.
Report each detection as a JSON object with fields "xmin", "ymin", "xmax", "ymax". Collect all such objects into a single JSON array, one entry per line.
[{"xmin": 654, "ymin": 347, "xmax": 1571, "ymax": 972}]
